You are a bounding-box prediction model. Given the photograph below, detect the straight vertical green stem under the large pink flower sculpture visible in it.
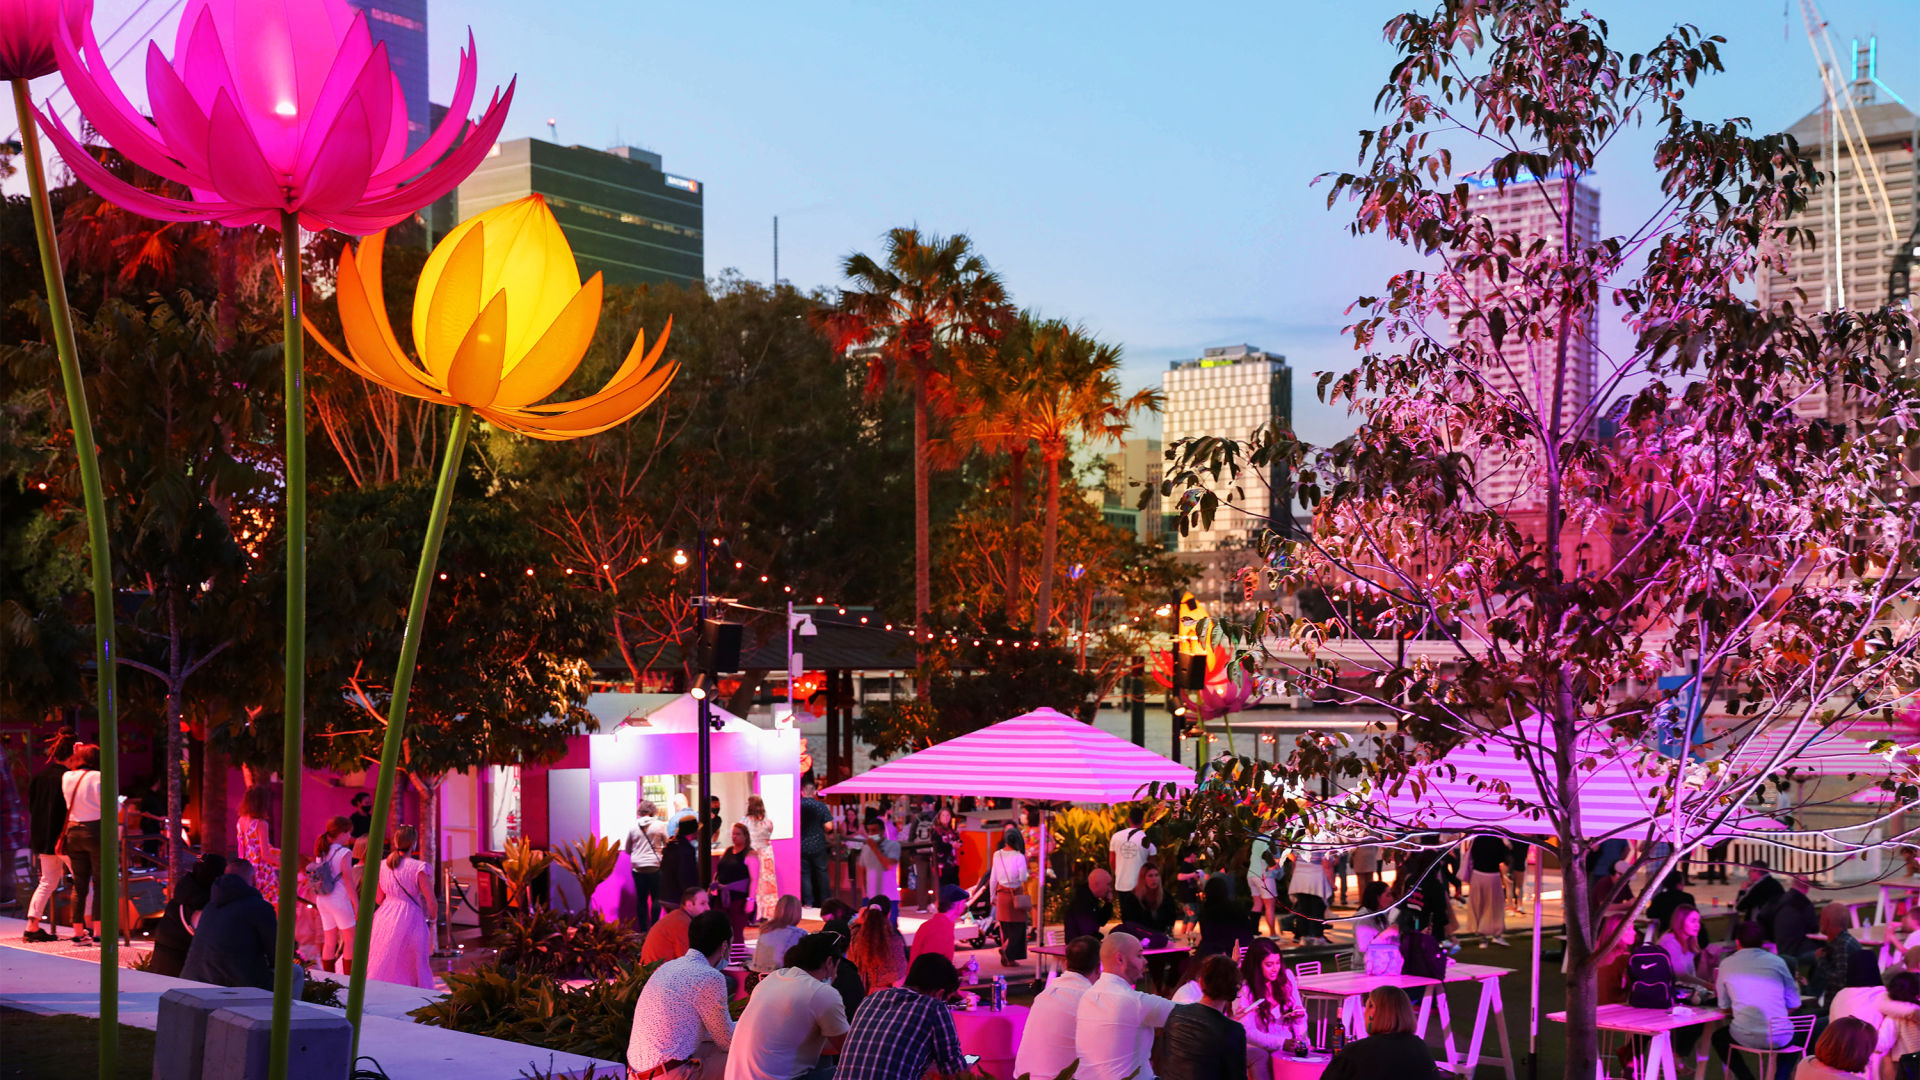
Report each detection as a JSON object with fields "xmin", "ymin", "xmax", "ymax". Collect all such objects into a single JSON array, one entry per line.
[{"xmin": 267, "ymin": 211, "xmax": 307, "ymax": 1080}]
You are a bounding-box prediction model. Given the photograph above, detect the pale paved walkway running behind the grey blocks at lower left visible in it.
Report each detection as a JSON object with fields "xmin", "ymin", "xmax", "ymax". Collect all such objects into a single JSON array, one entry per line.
[{"xmin": 0, "ymin": 919, "xmax": 624, "ymax": 1080}]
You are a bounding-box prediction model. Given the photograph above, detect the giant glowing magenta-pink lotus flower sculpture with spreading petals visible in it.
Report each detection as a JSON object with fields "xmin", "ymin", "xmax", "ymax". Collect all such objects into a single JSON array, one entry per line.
[{"xmin": 36, "ymin": 0, "xmax": 513, "ymax": 234}]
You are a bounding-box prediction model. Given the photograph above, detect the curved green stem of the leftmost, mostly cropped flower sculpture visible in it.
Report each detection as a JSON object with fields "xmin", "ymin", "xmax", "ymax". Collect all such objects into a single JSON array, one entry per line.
[{"xmin": 13, "ymin": 79, "xmax": 121, "ymax": 1080}]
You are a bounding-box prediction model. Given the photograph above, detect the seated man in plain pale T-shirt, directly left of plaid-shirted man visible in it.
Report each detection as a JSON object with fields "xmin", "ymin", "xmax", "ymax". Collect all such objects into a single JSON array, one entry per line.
[{"xmin": 726, "ymin": 934, "xmax": 847, "ymax": 1080}]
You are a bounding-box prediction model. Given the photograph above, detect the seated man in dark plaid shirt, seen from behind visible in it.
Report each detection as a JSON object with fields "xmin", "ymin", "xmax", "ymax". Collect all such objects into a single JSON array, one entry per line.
[{"xmin": 833, "ymin": 953, "xmax": 966, "ymax": 1080}]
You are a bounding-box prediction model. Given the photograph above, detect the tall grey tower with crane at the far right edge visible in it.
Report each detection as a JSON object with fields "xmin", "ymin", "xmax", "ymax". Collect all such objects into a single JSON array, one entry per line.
[{"xmin": 1759, "ymin": 40, "xmax": 1920, "ymax": 419}]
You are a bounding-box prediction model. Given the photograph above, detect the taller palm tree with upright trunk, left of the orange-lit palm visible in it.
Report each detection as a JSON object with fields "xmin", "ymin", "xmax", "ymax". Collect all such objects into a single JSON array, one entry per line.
[{"xmin": 822, "ymin": 229, "xmax": 1008, "ymax": 657}]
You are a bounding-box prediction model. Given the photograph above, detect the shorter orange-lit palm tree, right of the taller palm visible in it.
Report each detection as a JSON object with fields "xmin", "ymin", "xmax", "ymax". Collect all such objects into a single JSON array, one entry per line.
[{"xmin": 1016, "ymin": 323, "xmax": 1162, "ymax": 634}]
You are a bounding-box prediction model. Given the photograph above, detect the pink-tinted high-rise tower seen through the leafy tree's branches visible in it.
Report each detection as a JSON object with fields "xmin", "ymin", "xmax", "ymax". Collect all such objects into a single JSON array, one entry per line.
[{"xmin": 1467, "ymin": 177, "xmax": 1599, "ymax": 511}]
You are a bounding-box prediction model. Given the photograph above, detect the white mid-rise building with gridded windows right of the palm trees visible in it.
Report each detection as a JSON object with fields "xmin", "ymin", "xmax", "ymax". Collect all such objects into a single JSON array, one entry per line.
[{"xmin": 1162, "ymin": 346, "xmax": 1294, "ymax": 552}]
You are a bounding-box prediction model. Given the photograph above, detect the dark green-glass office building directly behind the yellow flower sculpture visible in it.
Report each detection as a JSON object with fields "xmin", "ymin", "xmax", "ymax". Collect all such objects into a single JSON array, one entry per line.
[{"xmin": 459, "ymin": 138, "xmax": 707, "ymax": 284}]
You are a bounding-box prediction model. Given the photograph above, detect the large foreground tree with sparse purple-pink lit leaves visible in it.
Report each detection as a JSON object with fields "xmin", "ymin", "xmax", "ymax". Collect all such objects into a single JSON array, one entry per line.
[{"xmin": 1164, "ymin": 0, "xmax": 1920, "ymax": 1076}]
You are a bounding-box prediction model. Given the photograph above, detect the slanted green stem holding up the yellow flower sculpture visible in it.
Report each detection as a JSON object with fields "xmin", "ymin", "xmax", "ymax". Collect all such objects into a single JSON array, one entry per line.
[{"xmin": 348, "ymin": 405, "xmax": 474, "ymax": 1057}]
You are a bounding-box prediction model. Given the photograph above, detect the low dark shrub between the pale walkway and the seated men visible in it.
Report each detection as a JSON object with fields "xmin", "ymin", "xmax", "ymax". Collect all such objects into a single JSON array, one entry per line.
[{"xmin": 409, "ymin": 953, "xmax": 659, "ymax": 1061}]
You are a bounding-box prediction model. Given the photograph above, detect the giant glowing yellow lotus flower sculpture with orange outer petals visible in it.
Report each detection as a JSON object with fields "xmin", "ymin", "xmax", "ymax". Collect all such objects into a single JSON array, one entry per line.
[{"xmin": 307, "ymin": 194, "xmax": 678, "ymax": 438}]
